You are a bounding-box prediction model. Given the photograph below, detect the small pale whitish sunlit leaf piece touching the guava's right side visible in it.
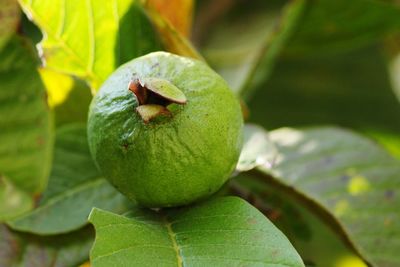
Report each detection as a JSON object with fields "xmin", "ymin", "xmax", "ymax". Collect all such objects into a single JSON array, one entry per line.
[{"xmin": 236, "ymin": 124, "xmax": 276, "ymax": 172}]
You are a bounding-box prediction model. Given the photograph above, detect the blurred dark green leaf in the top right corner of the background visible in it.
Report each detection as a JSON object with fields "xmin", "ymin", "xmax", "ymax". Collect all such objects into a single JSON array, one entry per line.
[{"xmin": 286, "ymin": 0, "xmax": 400, "ymax": 56}]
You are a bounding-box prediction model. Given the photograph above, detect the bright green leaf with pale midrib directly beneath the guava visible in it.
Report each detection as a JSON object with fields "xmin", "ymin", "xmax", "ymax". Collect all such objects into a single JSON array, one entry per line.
[{"xmin": 89, "ymin": 197, "xmax": 304, "ymax": 267}]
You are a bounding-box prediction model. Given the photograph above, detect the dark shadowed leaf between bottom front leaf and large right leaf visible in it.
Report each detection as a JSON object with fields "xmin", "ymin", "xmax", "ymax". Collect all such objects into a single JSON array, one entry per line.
[{"xmin": 230, "ymin": 174, "xmax": 367, "ymax": 267}]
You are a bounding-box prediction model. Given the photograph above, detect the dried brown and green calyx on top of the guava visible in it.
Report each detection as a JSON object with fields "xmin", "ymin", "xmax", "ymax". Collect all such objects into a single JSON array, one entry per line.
[{"xmin": 128, "ymin": 77, "xmax": 187, "ymax": 123}]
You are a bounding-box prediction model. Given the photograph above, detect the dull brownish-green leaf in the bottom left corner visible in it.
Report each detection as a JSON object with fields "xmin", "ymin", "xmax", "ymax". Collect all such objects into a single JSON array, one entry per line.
[{"xmin": 0, "ymin": 225, "xmax": 94, "ymax": 267}]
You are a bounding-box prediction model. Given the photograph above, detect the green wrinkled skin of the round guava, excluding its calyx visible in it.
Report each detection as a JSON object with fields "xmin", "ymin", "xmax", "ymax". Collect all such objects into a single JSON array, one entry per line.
[{"xmin": 88, "ymin": 52, "xmax": 243, "ymax": 207}]
